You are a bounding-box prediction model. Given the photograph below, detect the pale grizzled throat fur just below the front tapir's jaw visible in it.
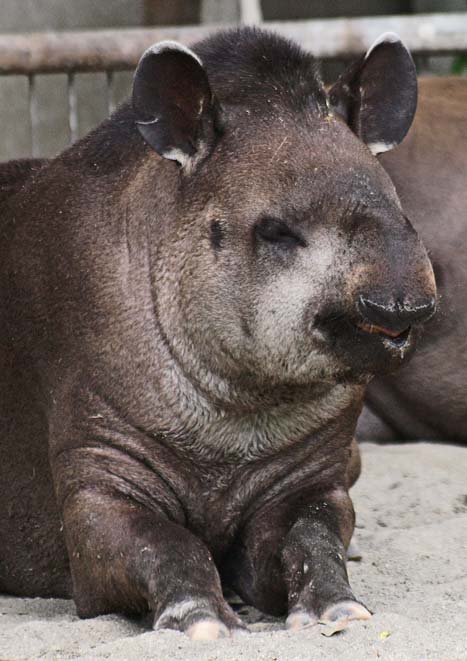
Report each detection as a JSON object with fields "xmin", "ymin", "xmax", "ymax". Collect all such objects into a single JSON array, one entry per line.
[{"xmin": 152, "ymin": 310, "xmax": 363, "ymax": 462}]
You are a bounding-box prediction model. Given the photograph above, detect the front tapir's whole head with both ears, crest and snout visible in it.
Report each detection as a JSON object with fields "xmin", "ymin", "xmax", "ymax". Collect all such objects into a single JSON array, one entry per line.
[{"xmin": 133, "ymin": 29, "xmax": 436, "ymax": 384}]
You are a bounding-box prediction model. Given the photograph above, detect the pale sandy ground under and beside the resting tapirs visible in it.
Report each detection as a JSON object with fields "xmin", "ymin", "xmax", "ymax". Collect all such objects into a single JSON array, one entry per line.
[{"xmin": 0, "ymin": 443, "xmax": 467, "ymax": 661}]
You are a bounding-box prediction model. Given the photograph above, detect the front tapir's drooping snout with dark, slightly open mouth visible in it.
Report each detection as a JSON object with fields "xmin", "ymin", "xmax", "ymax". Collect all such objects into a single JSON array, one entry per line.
[{"xmin": 315, "ymin": 214, "xmax": 437, "ymax": 374}]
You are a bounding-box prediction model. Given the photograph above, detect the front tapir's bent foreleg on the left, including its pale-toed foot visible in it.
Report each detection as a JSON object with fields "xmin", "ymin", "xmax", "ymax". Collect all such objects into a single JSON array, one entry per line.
[{"xmin": 64, "ymin": 489, "xmax": 243, "ymax": 639}]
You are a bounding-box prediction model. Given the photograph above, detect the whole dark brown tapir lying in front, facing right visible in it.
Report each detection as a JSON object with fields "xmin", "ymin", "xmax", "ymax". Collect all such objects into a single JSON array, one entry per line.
[{"xmin": 0, "ymin": 29, "xmax": 436, "ymax": 638}]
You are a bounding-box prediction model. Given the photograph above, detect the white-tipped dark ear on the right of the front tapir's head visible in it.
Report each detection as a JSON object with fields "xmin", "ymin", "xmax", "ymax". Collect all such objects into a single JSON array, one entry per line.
[{"xmin": 329, "ymin": 32, "xmax": 417, "ymax": 154}]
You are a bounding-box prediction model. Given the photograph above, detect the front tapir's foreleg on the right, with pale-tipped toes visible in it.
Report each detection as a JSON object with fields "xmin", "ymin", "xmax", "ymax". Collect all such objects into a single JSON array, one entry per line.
[{"xmin": 224, "ymin": 487, "xmax": 370, "ymax": 629}]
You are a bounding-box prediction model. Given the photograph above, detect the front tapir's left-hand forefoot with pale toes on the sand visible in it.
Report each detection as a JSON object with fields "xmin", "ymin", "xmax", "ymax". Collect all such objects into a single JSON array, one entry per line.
[{"xmin": 154, "ymin": 599, "xmax": 248, "ymax": 640}]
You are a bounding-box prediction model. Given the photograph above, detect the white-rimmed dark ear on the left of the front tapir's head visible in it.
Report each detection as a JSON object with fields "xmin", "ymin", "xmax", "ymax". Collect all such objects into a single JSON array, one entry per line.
[{"xmin": 133, "ymin": 41, "xmax": 220, "ymax": 167}]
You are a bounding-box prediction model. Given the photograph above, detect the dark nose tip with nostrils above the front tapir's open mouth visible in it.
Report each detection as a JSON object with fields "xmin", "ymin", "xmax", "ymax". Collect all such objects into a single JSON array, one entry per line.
[{"xmin": 357, "ymin": 296, "xmax": 436, "ymax": 332}]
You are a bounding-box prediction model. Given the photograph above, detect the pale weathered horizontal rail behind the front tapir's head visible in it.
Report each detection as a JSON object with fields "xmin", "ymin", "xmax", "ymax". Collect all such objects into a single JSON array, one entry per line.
[{"xmin": 0, "ymin": 13, "xmax": 467, "ymax": 74}]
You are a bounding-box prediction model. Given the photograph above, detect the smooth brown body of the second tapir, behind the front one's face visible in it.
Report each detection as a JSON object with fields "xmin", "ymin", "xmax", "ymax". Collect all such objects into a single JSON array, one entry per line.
[{"xmin": 361, "ymin": 78, "xmax": 467, "ymax": 442}]
